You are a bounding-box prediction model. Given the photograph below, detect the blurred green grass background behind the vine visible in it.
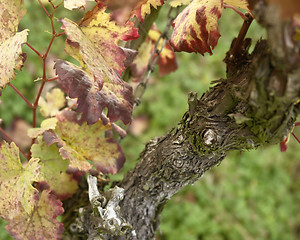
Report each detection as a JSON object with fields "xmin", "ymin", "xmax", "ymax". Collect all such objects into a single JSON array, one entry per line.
[{"xmin": 0, "ymin": 0, "xmax": 300, "ymax": 240}]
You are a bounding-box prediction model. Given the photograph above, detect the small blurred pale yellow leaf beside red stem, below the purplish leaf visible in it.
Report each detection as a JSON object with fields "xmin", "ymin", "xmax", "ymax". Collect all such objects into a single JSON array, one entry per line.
[{"xmin": 39, "ymin": 88, "xmax": 66, "ymax": 117}]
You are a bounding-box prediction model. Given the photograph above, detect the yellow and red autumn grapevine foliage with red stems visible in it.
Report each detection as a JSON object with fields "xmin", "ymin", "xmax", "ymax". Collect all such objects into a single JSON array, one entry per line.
[{"xmin": 0, "ymin": 0, "xmax": 253, "ymax": 240}]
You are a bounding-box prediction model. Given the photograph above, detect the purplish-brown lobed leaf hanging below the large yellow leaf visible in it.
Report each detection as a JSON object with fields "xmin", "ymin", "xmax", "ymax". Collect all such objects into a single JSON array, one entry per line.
[{"xmin": 55, "ymin": 60, "xmax": 133, "ymax": 124}]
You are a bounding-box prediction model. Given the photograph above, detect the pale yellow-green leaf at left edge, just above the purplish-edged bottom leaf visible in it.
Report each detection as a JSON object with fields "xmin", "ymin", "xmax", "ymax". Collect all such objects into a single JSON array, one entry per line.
[{"xmin": 0, "ymin": 142, "xmax": 40, "ymax": 221}]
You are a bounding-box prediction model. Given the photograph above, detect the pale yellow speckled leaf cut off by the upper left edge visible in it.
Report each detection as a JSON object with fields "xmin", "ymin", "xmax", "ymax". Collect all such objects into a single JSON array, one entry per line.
[{"xmin": 0, "ymin": 0, "xmax": 28, "ymax": 89}]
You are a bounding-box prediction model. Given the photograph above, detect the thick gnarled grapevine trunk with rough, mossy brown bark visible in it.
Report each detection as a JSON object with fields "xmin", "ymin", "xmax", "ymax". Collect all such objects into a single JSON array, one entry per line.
[{"xmin": 65, "ymin": 1, "xmax": 300, "ymax": 240}]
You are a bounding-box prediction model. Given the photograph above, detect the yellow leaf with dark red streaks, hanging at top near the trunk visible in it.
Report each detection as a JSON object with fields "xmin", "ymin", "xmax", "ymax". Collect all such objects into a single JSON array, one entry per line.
[{"xmin": 170, "ymin": 0, "xmax": 223, "ymax": 55}]
